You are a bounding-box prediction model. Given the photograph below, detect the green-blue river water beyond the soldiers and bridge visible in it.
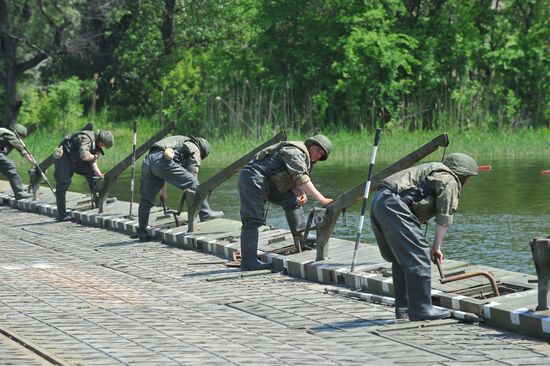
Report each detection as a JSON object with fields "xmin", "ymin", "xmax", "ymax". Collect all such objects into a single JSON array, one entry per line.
[{"xmin": 80, "ymin": 158, "xmax": 550, "ymax": 274}]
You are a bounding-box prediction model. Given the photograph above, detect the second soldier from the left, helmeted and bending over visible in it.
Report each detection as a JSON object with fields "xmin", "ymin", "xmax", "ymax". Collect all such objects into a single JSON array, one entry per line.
[{"xmin": 54, "ymin": 131, "xmax": 115, "ymax": 221}]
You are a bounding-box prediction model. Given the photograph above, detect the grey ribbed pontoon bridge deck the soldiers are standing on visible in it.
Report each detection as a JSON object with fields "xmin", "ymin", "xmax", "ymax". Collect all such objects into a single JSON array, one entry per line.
[{"xmin": 0, "ymin": 182, "xmax": 550, "ymax": 365}]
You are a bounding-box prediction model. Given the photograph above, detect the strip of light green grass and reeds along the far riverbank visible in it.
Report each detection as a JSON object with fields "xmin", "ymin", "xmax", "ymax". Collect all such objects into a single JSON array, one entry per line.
[{"xmin": 6, "ymin": 121, "xmax": 550, "ymax": 170}]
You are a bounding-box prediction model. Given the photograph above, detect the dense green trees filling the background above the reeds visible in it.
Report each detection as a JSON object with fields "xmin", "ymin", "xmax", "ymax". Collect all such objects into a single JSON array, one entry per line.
[{"xmin": 0, "ymin": 0, "xmax": 550, "ymax": 135}]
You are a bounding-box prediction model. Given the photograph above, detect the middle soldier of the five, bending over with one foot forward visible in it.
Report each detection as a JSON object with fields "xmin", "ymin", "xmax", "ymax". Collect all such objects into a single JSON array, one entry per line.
[{"xmin": 137, "ymin": 136, "xmax": 223, "ymax": 241}]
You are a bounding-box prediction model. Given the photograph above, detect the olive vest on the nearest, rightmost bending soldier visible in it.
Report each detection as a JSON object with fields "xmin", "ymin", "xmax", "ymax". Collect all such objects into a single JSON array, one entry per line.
[{"xmin": 381, "ymin": 163, "xmax": 461, "ymax": 223}]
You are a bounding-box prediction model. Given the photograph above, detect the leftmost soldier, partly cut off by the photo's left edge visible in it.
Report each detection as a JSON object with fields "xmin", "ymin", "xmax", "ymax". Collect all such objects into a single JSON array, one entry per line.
[{"xmin": 0, "ymin": 123, "xmax": 34, "ymax": 200}]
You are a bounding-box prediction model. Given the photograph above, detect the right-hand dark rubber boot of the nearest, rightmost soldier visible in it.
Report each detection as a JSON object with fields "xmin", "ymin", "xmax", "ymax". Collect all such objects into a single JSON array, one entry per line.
[{"xmin": 405, "ymin": 273, "xmax": 451, "ymax": 321}]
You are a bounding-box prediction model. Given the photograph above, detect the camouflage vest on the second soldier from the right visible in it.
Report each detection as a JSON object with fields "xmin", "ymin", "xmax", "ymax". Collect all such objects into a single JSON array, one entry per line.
[{"xmin": 254, "ymin": 141, "xmax": 312, "ymax": 193}]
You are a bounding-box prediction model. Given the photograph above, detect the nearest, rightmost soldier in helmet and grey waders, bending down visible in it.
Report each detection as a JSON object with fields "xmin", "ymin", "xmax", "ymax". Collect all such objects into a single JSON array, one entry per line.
[{"xmin": 370, "ymin": 153, "xmax": 478, "ymax": 320}]
